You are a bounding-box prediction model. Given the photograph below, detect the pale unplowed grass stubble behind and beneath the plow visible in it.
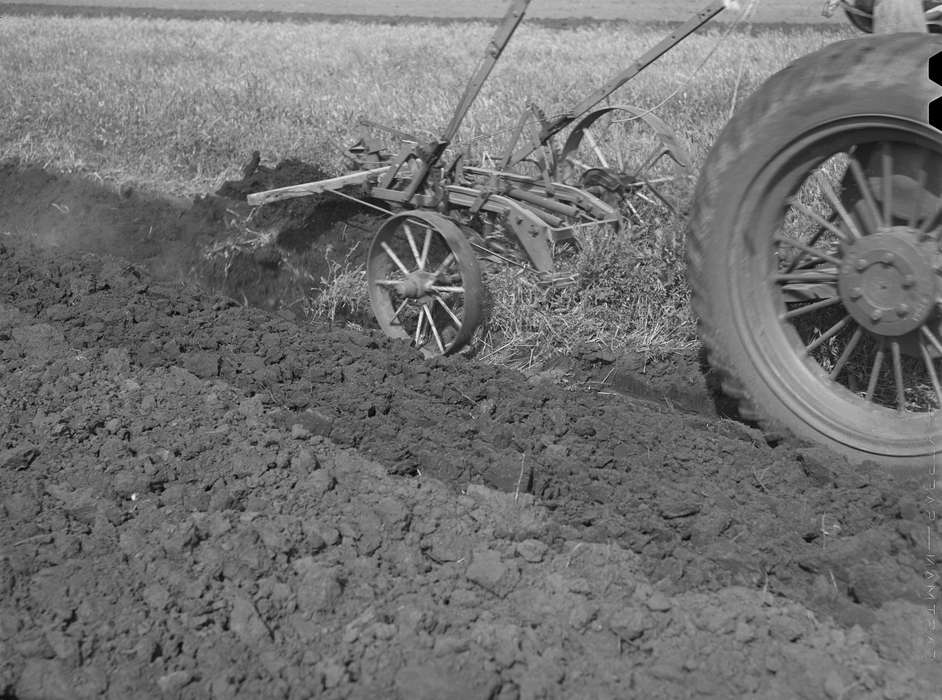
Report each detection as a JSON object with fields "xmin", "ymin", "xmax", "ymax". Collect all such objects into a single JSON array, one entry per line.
[{"xmin": 0, "ymin": 17, "xmax": 851, "ymax": 365}]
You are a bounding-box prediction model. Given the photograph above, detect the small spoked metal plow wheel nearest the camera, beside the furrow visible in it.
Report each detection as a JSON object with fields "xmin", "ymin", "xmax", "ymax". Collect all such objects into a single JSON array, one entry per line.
[{"xmin": 367, "ymin": 211, "xmax": 483, "ymax": 356}]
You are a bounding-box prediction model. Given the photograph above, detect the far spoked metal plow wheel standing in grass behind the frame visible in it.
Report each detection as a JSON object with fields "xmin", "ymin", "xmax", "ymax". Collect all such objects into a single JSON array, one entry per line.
[{"xmin": 559, "ymin": 105, "xmax": 690, "ymax": 220}]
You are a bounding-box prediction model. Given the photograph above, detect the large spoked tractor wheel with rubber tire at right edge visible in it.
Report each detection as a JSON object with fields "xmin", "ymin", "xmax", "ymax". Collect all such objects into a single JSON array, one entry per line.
[{"xmin": 687, "ymin": 34, "xmax": 942, "ymax": 472}]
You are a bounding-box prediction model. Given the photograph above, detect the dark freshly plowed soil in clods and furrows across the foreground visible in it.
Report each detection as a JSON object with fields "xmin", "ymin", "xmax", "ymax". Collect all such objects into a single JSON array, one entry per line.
[{"xmin": 0, "ymin": 164, "xmax": 942, "ymax": 700}]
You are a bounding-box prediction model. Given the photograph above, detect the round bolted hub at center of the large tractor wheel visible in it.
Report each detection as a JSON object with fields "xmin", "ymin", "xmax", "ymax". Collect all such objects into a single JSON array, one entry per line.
[{"xmin": 838, "ymin": 226, "xmax": 937, "ymax": 336}]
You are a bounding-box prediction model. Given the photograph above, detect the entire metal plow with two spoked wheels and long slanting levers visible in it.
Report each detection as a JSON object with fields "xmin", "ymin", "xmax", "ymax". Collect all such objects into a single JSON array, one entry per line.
[{"xmin": 248, "ymin": 0, "xmax": 725, "ymax": 355}]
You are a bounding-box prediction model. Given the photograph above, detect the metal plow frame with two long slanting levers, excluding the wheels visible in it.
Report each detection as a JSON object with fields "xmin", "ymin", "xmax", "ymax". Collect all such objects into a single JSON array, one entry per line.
[{"xmin": 247, "ymin": 0, "xmax": 727, "ymax": 281}]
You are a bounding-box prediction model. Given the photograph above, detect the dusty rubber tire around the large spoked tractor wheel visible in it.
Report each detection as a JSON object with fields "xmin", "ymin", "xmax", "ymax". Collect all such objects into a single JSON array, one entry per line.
[{"xmin": 686, "ymin": 34, "xmax": 942, "ymax": 474}]
